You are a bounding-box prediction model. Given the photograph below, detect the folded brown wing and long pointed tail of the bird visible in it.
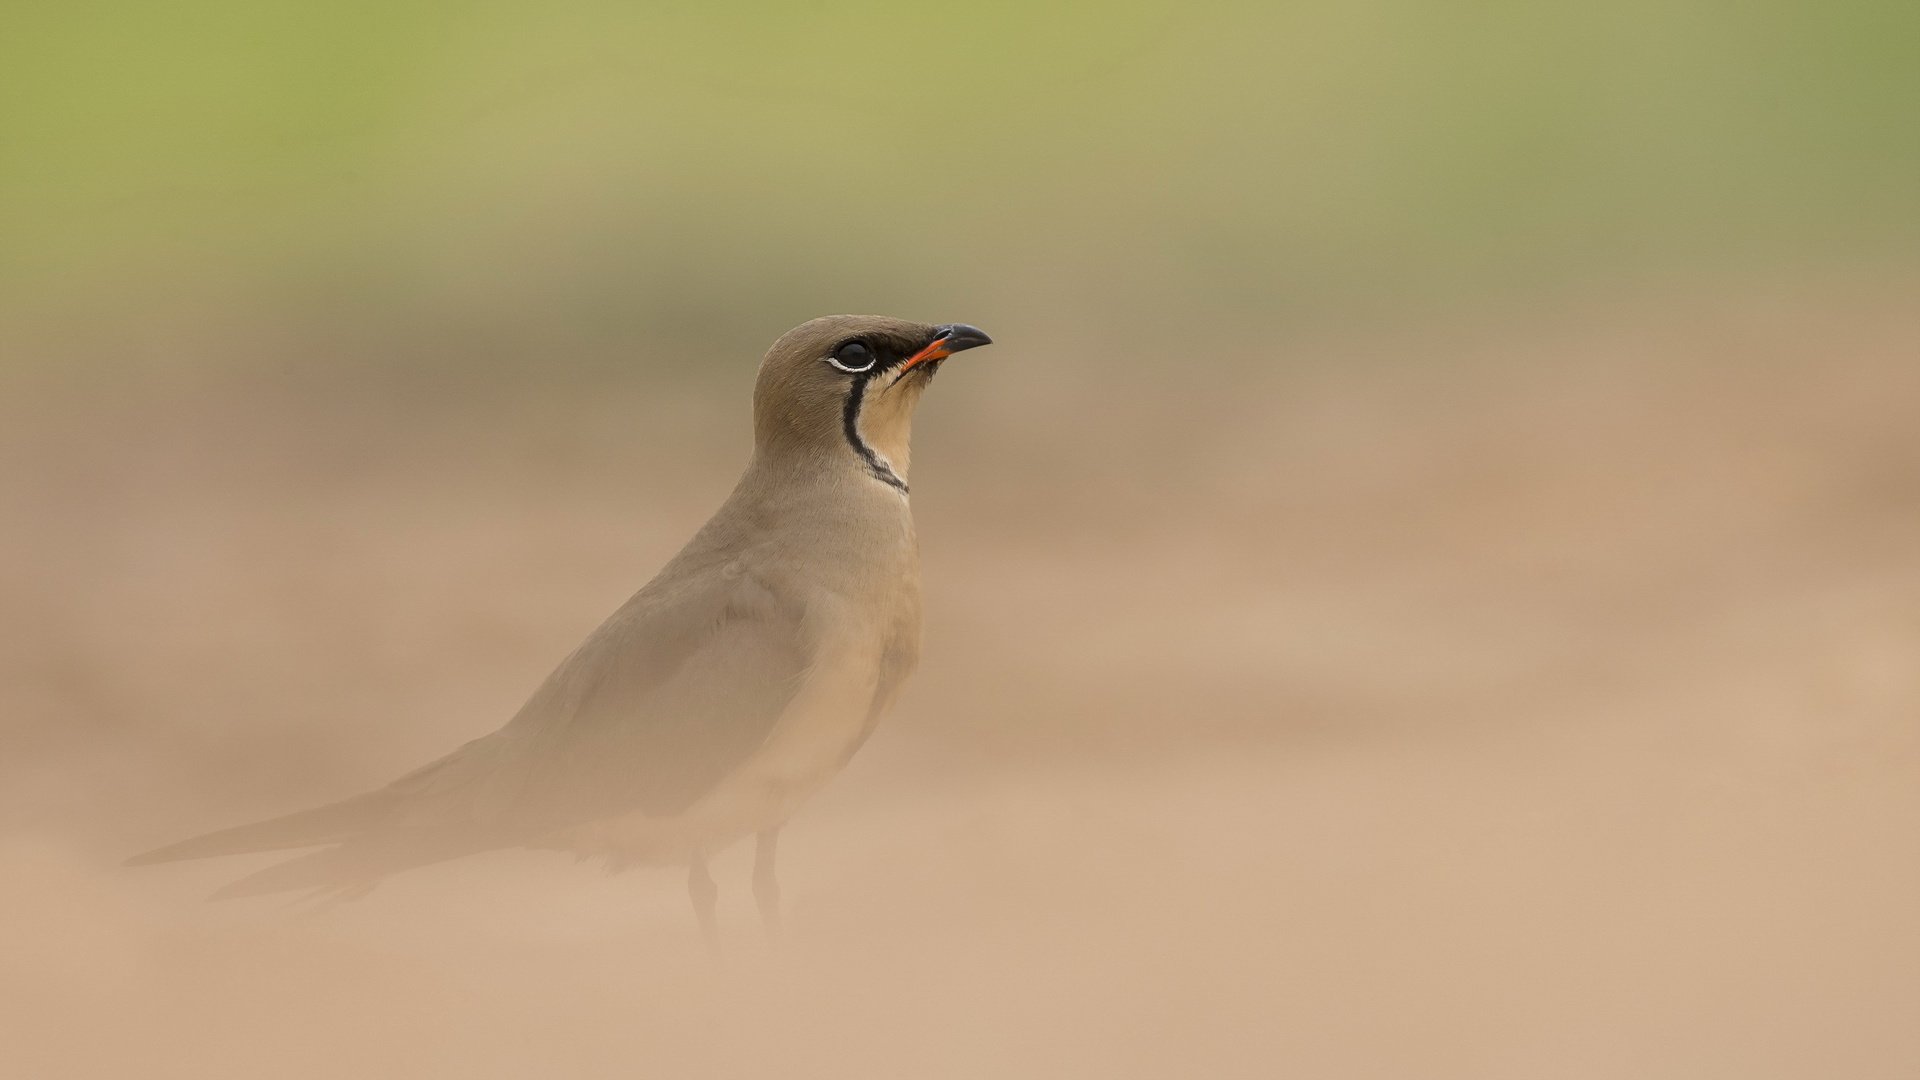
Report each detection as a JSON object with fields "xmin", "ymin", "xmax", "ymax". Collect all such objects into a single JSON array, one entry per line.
[{"xmin": 136, "ymin": 567, "xmax": 810, "ymax": 896}]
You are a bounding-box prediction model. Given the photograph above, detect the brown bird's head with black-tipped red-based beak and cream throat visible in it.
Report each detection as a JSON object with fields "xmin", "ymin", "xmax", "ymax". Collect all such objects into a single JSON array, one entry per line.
[{"xmin": 753, "ymin": 315, "xmax": 993, "ymax": 492}]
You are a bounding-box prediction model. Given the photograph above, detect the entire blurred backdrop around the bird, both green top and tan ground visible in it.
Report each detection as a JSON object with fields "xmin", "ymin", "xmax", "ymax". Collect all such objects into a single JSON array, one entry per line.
[{"xmin": 0, "ymin": 2, "xmax": 1920, "ymax": 1080}]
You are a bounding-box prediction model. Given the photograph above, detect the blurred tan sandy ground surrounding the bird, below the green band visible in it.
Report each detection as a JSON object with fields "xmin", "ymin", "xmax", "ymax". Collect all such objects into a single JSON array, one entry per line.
[{"xmin": 0, "ymin": 275, "xmax": 1920, "ymax": 1078}]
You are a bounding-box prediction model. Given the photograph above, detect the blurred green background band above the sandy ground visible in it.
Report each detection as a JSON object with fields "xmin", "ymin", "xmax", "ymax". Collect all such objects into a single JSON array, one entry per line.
[{"xmin": 0, "ymin": 0, "xmax": 1920, "ymax": 379}]
